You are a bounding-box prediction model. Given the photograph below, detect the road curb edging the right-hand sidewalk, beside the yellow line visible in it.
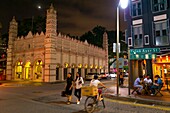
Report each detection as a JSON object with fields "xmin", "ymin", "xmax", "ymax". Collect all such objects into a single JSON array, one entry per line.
[{"xmin": 104, "ymin": 94, "xmax": 170, "ymax": 107}]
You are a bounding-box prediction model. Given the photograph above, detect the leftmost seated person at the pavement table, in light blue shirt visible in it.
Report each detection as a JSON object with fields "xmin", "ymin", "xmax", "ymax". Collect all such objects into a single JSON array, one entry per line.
[{"xmin": 133, "ymin": 76, "xmax": 143, "ymax": 95}]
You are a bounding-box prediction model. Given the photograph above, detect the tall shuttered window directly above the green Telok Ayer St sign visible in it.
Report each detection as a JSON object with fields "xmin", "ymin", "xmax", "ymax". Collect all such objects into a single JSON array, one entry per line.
[{"xmin": 133, "ymin": 25, "xmax": 143, "ymax": 48}]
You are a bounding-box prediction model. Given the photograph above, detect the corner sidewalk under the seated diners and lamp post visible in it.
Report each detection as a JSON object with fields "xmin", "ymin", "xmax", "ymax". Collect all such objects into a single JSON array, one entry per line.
[{"xmin": 105, "ymin": 86, "xmax": 170, "ymax": 107}]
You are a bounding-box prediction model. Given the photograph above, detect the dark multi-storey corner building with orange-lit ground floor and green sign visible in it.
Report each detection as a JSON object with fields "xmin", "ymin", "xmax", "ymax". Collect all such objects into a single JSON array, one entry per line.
[{"xmin": 125, "ymin": 0, "xmax": 170, "ymax": 85}]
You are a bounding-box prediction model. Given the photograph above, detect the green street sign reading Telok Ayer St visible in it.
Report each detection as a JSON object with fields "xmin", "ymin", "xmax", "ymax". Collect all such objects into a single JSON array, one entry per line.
[{"xmin": 130, "ymin": 48, "xmax": 160, "ymax": 54}]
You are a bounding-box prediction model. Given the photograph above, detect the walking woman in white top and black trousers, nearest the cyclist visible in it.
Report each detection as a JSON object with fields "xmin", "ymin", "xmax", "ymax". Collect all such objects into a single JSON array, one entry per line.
[{"xmin": 74, "ymin": 72, "xmax": 84, "ymax": 104}]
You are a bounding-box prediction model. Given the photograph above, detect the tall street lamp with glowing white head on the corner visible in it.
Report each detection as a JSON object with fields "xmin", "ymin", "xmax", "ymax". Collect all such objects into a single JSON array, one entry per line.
[{"xmin": 116, "ymin": 0, "xmax": 128, "ymax": 96}]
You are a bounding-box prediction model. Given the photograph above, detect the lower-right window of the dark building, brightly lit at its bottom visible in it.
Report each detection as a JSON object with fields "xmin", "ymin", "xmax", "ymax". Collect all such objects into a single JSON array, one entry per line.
[{"xmin": 154, "ymin": 21, "xmax": 169, "ymax": 46}]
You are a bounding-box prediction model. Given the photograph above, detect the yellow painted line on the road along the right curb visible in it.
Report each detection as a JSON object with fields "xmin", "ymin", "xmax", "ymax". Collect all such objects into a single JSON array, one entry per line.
[{"xmin": 105, "ymin": 98, "xmax": 170, "ymax": 111}]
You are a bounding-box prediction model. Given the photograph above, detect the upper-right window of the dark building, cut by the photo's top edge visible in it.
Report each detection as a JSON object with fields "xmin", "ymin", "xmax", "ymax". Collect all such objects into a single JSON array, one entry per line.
[{"xmin": 152, "ymin": 0, "xmax": 167, "ymax": 12}]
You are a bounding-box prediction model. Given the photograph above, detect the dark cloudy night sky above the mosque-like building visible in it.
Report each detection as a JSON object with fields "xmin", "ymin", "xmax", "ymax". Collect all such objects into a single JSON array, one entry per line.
[{"xmin": 0, "ymin": 0, "xmax": 125, "ymax": 36}]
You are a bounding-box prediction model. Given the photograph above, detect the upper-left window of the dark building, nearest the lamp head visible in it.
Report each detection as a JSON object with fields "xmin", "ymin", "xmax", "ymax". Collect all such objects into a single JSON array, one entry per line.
[{"xmin": 132, "ymin": 0, "xmax": 142, "ymax": 17}]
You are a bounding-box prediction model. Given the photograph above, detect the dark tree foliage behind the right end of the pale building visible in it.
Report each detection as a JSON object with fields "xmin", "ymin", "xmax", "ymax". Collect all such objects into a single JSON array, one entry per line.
[{"xmin": 80, "ymin": 26, "xmax": 127, "ymax": 58}]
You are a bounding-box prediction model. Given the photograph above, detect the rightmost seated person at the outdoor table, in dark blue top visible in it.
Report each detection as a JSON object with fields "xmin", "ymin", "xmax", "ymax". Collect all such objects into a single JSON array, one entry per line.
[{"xmin": 150, "ymin": 75, "xmax": 162, "ymax": 96}]
